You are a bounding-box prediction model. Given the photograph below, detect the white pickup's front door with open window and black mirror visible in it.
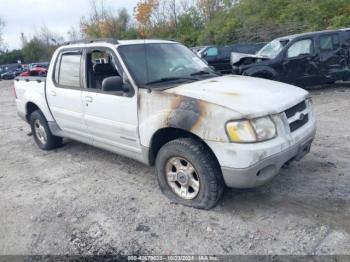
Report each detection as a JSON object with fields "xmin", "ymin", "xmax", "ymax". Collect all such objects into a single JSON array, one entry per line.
[{"xmin": 82, "ymin": 48, "xmax": 141, "ymax": 157}]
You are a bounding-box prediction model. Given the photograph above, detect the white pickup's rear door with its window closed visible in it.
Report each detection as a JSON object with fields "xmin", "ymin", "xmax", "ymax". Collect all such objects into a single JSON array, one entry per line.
[{"xmin": 46, "ymin": 50, "xmax": 91, "ymax": 142}]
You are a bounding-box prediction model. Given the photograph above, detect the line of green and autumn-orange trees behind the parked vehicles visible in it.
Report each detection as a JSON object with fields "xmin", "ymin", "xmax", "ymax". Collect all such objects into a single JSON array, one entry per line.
[{"xmin": 0, "ymin": 0, "xmax": 350, "ymax": 64}]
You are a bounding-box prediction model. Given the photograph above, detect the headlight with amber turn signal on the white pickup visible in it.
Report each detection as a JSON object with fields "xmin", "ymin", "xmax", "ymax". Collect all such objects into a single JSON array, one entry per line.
[{"xmin": 226, "ymin": 117, "xmax": 277, "ymax": 143}]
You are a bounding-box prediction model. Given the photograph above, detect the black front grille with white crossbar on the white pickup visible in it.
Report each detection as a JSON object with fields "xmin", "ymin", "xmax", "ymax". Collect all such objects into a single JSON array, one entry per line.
[{"xmin": 284, "ymin": 101, "xmax": 309, "ymax": 132}]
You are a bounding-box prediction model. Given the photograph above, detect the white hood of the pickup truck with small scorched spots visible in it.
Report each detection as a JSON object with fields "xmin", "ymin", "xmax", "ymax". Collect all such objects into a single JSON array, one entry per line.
[{"xmin": 163, "ymin": 75, "xmax": 308, "ymax": 118}]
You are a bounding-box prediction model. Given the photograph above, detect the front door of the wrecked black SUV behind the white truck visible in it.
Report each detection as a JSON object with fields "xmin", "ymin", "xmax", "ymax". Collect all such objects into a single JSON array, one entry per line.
[{"xmin": 281, "ymin": 38, "xmax": 322, "ymax": 87}]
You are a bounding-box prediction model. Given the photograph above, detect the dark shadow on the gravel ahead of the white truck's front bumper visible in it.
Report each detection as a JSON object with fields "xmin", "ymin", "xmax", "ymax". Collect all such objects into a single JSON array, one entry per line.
[{"xmin": 219, "ymin": 159, "xmax": 350, "ymax": 233}]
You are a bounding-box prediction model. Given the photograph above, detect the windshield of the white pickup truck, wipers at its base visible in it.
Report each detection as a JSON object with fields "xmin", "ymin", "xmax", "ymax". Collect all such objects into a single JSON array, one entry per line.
[{"xmin": 118, "ymin": 43, "xmax": 218, "ymax": 88}]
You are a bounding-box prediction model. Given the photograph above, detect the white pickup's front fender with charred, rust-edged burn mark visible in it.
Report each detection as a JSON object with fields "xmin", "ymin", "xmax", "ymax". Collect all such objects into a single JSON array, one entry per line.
[{"xmin": 138, "ymin": 83, "xmax": 252, "ymax": 147}]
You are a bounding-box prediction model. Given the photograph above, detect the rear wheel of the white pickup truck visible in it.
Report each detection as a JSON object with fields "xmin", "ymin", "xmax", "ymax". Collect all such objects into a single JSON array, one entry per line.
[{"xmin": 30, "ymin": 110, "xmax": 62, "ymax": 150}]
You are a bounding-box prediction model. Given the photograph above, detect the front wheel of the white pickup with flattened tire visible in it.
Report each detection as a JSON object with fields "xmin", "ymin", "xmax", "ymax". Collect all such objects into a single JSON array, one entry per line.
[{"xmin": 156, "ymin": 138, "xmax": 224, "ymax": 209}]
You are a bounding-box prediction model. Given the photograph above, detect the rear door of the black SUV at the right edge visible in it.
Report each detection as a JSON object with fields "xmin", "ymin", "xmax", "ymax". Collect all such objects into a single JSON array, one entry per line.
[{"xmin": 318, "ymin": 33, "xmax": 349, "ymax": 81}]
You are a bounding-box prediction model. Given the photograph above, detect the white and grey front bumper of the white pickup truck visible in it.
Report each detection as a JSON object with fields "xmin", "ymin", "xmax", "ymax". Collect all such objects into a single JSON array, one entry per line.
[{"xmin": 208, "ymin": 113, "xmax": 316, "ymax": 188}]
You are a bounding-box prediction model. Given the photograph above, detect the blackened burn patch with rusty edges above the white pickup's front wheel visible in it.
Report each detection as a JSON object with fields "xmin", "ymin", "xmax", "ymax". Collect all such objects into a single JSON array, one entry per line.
[{"xmin": 166, "ymin": 96, "xmax": 204, "ymax": 131}]
